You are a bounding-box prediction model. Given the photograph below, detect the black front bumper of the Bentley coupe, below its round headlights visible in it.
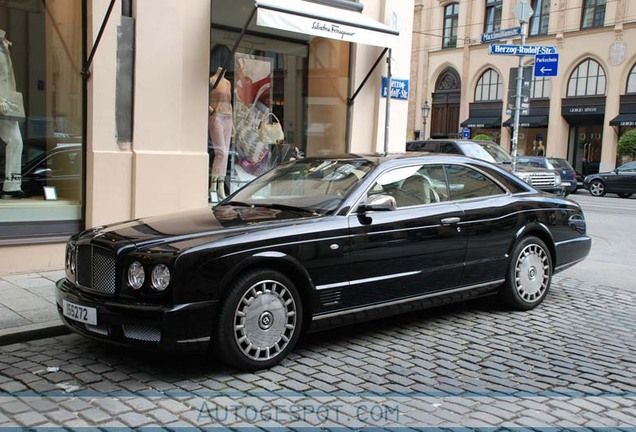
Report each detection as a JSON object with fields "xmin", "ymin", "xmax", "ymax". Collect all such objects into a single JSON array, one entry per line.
[{"xmin": 55, "ymin": 279, "xmax": 218, "ymax": 350}]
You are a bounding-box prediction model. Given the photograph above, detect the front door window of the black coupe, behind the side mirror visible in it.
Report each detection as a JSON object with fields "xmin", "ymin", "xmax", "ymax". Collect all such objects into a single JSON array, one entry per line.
[{"xmin": 369, "ymin": 165, "xmax": 448, "ymax": 208}]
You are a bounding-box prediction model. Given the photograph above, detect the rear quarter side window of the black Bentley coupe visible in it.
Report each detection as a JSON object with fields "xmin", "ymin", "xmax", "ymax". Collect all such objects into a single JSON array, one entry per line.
[{"xmin": 446, "ymin": 165, "xmax": 506, "ymax": 201}]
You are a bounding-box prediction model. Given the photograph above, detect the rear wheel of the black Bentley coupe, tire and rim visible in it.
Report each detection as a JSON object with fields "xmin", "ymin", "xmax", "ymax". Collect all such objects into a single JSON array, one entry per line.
[{"xmin": 501, "ymin": 236, "xmax": 553, "ymax": 310}]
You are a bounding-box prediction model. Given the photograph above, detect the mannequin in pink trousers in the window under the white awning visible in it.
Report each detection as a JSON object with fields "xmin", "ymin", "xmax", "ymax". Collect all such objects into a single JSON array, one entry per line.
[{"xmin": 208, "ymin": 68, "xmax": 232, "ymax": 199}]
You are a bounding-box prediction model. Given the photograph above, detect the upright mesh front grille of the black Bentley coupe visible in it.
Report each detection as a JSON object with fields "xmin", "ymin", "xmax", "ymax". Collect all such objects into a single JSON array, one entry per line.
[{"xmin": 77, "ymin": 245, "xmax": 115, "ymax": 296}]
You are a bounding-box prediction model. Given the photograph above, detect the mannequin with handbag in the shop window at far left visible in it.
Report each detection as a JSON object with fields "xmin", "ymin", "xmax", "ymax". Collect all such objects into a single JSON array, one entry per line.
[{"xmin": 0, "ymin": 29, "xmax": 26, "ymax": 199}]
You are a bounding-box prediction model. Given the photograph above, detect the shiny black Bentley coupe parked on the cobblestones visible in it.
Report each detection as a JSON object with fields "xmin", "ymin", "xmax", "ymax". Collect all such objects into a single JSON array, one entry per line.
[{"xmin": 57, "ymin": 153, "xmax": 591, "ymax": 370}]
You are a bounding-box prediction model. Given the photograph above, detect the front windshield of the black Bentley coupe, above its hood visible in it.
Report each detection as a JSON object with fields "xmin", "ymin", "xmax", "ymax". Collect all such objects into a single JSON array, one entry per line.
[{"xmin": 221, "ymin": 159, "xmax": 374, "ymax": 214}]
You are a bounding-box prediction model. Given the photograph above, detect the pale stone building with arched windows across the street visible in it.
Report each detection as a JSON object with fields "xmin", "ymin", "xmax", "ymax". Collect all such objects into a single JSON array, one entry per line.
[{"xmin": 407, "ymin": 0, "xmax": 636, "ymax": 174}]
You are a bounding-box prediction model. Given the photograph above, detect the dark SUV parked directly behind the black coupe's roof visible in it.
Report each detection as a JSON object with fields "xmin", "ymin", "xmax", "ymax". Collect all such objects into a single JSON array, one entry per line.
[{"xmin": 406, "ymin": 139, "xmax": 565, "ymax": 195}]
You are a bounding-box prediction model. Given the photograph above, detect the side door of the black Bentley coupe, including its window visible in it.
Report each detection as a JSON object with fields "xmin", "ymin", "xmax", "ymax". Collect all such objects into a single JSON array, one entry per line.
[{"xmin": 343, "ymin": 164, "xmax": 466, "ymax": 306}]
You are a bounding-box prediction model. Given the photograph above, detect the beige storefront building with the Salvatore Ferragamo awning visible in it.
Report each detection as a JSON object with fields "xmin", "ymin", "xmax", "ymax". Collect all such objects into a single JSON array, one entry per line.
[{"xmin": 0, "ymin": 0, "xmax": 414, "ymax": 273}]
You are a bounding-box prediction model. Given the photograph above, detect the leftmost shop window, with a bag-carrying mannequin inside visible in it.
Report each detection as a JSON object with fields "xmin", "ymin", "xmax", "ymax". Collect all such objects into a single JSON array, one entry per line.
[{"xmin": 0, "ymin": 0, "xmax": 84, "ymax": 238}]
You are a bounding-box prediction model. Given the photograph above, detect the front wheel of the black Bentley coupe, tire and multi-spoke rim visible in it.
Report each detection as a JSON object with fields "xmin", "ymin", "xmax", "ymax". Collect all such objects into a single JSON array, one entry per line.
[{"xmin": 214, "ymin": 270, "xmax": 303, "ymax": 370}]
